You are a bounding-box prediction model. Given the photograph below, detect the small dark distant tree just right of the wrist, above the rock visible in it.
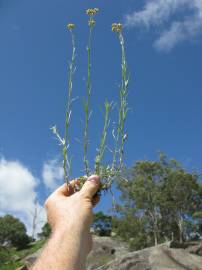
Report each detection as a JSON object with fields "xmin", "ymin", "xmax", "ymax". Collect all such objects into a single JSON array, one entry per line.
[{"xmin": 92, "ymin": 211, "xmax": 112, "ymax": 236}]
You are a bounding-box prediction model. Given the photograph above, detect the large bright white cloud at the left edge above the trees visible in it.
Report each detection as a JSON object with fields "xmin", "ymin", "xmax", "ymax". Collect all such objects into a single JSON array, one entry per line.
[{"xmin": 0, "ymin": 158, "xmax": 45, "ymax": 234}]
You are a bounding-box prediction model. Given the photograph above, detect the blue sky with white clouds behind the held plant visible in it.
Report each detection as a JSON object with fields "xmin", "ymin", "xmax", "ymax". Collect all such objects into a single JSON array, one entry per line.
[{"xmin": 0, "ymin": 0, "xmax": 202, "ymax": 232}]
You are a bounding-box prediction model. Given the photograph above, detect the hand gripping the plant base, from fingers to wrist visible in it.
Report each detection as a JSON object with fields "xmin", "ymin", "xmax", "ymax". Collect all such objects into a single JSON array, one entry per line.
[{"xmin": 45, "ymin": 175, "xmax": 100, "ymax": 253}]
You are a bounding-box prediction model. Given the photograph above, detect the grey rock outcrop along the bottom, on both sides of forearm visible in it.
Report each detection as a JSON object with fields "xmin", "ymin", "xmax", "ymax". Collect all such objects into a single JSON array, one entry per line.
[{"xmin": 20, "ymin": 236, "xmax": 202, "ymax": 270}]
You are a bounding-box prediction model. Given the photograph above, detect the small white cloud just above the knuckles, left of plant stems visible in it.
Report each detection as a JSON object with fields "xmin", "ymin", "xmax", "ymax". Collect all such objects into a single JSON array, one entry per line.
[{"xmin": 42, "ymin": 159, "xmax": 63, "ymax": 191}]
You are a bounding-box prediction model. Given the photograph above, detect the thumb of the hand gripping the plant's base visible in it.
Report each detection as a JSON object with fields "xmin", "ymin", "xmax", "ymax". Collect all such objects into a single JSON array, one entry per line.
[{"xmin": 80, "ymin": 175, "xmax": 100, "ymax": 199}]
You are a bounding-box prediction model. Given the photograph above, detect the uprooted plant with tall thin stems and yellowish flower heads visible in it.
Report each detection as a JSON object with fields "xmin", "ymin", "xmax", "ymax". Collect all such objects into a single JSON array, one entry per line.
[{"xmin": 52, "ymin": 8, "xmax": 129, "ymax": 190}]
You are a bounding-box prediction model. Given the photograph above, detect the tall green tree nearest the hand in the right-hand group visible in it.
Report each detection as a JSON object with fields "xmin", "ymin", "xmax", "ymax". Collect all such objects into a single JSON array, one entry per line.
[{"xmin": 119, "ymin": 161, "xmax": 164, "ymax": 245}]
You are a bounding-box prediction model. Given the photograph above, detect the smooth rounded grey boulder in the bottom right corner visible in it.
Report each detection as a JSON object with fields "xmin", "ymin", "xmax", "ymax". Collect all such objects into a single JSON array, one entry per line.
[{"xmin": 98, "ymin": 245, "xmax": 202, "ymax": 270}]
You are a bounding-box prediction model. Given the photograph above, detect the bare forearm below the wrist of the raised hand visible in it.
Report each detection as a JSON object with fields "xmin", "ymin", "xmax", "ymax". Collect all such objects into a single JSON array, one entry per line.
[{"xmin": 32, "ymin": 228, "xmax": 87, "ymax": 270}]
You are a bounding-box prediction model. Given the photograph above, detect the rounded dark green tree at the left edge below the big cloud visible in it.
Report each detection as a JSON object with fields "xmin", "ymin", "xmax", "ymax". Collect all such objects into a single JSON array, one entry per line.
[{"xmin": 0, "ymin": 215, "xmax": 30, "ymax": 249}]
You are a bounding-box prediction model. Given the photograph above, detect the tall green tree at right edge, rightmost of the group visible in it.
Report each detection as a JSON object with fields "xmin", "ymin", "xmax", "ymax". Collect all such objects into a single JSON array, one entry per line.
[{"xmin": 162, "ymin": 169, "xmax": 202, "ymax": 242}]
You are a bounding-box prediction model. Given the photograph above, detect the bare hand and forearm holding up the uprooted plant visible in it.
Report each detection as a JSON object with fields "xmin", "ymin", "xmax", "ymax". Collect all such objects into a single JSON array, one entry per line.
[{"xmin": 32, "ymin": 175, "xmax": 100, "ymax": 270}]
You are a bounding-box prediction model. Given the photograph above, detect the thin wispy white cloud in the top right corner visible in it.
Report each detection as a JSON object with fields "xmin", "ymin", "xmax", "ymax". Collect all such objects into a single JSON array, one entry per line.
[{"xmin": 125, "ymin": 0, "xmax": 202, "ymax": 51}]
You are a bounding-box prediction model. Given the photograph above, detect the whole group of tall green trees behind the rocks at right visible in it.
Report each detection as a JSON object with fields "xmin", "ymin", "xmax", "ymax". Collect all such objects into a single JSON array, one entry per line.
[{"xmin": 114, "ymin": 155, "xmax": 202, "ymax": 249}]
